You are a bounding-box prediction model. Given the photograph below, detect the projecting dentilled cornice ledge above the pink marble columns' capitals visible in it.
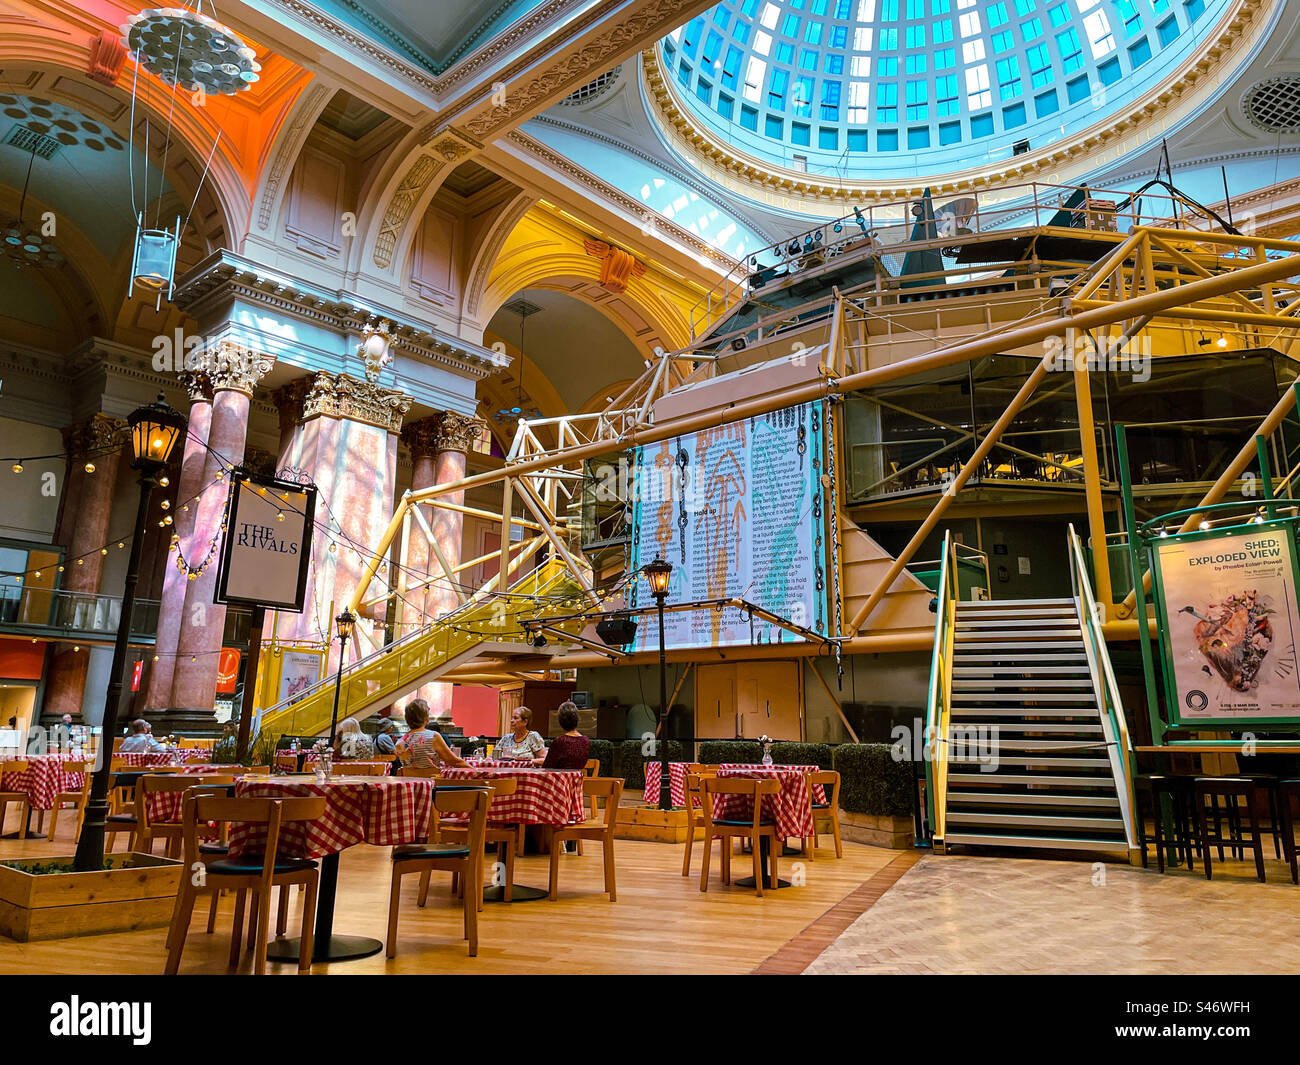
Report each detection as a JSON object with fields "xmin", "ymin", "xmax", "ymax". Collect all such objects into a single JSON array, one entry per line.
[{"xmin": 173, "ymin": 251, "xmax": 511, "ymax": 380}]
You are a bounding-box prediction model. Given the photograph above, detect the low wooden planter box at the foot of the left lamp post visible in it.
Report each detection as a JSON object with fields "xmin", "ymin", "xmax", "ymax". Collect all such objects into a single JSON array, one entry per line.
[{"xmin": 0, "ymin": 853, "xmax": 181, "ymax": 943}]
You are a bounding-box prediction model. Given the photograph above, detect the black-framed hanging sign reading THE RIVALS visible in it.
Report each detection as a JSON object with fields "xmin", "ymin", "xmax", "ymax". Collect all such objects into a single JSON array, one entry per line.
[{"xmin": 216, "ymin": 469, "xmax": 316, "ymax": 614}]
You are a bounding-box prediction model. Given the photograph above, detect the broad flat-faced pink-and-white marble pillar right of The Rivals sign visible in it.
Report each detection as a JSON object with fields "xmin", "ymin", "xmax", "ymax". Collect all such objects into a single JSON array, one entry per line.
[{"xmin": 276, "ymin": 373, "xmax": 412, "ymax": 670}]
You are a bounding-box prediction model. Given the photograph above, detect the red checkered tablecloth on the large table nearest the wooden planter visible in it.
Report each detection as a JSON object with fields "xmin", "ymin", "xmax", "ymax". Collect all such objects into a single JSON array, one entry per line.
[{"xmin": 230, "ymin": 776, "xmax": 434, "ymax": 858}]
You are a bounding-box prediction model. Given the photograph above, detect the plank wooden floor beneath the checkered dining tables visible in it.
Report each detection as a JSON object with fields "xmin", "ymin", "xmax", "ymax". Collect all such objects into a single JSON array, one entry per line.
[{"xmin": 0, "ymin": 814, "xmax": 898, "ymax": 975}]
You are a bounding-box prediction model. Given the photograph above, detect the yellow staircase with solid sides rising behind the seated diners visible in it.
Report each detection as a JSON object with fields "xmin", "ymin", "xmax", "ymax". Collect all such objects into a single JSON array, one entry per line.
[{"xmin": 257, "ymin": 558, "xmax": 585, "ymax": 736}]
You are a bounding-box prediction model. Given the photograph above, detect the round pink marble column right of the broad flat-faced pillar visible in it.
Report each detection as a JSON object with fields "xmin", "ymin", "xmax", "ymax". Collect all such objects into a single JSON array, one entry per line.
[{"xmin": 402, "ymin": 411, "xmax": 484, "ymax": 720}]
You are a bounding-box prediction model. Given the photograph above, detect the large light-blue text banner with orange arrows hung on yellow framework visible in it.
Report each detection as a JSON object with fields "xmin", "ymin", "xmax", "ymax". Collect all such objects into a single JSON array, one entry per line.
[{"xmin": 629, "ymin": 403, "xmax": 828, "ymax": 650}]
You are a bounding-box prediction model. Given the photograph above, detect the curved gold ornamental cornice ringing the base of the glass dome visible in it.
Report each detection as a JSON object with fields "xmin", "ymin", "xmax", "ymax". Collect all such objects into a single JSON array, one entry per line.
[{"xmin": 641, "ymin": 0, "xmax": 1273, "ymax": 205}]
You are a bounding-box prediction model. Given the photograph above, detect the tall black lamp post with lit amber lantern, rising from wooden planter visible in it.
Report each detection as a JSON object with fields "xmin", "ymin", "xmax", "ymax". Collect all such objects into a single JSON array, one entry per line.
[{"xmin": 73, "ymin": 393, "xmax": 186, "ymax": 873}]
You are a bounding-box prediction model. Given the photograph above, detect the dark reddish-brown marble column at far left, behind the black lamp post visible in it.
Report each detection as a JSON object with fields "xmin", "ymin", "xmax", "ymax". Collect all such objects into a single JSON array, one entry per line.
[{"xmin": 42, "ymin": 414, "xmax": 126, "ymax": 722}]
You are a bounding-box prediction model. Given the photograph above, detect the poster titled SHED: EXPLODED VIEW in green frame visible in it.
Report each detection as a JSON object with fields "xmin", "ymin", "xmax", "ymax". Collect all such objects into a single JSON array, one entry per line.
[{"xmin": 1156, "ymin": 524, "xmax": 1300, "ymax": 722}]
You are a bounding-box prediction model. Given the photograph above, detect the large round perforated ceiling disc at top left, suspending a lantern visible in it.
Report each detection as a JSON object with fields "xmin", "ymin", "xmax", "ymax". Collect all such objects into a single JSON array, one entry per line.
[{"xmin": 121, "ymin": 8, "xmax": 261, "ymax": 96}]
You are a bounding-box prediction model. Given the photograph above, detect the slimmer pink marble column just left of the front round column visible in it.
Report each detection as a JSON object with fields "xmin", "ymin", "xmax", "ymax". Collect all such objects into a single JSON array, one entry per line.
[{"xmin": 144, "ymin": 371, "xmax": 212, "ymax": 717}]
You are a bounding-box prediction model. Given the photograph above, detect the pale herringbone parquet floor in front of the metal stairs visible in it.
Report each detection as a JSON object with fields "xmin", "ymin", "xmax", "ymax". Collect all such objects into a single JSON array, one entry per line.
[{"xmin": 806, "ymin": 854, "xmax": 1300, "ymax": 975}]
